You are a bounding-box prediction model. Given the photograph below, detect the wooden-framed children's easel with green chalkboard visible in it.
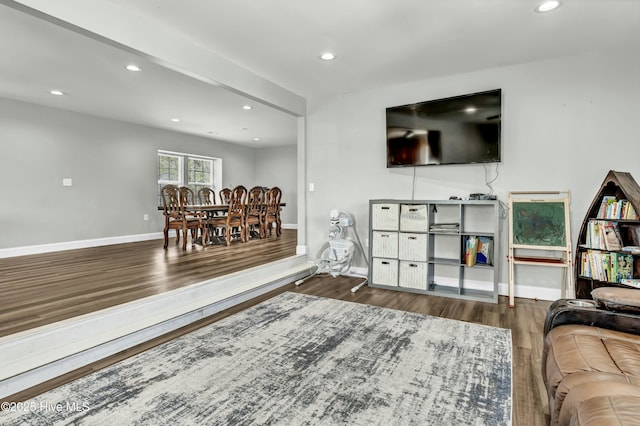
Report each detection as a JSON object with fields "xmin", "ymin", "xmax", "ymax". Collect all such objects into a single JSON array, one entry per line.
[{"xmin": 508, "ymin": 191, "xmax": 575, "ymax": 308}]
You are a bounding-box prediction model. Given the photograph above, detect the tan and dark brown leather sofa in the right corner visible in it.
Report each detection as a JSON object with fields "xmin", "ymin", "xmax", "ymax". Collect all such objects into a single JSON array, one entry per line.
[{"xmin": 542, "ymin": 287, "xmax": 640, "ymax": 426}]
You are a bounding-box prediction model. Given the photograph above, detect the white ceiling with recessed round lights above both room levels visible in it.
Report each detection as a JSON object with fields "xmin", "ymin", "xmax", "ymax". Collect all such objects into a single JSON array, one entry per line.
[{"xmin": 0, "ymin": 0, "xmax": 640, "ymax": 147}]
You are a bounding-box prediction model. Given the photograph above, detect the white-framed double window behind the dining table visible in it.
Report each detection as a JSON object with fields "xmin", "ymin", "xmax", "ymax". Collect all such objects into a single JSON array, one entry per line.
[{"xmin": 158, "ymin": 151, "xmax": 221, "ymax": 205}]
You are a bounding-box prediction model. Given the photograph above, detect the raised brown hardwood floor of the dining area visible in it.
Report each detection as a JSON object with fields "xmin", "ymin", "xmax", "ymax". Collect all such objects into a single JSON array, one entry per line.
[{"xmin": 0, "ymin": 229, "xmax": 297, "ymax": 337}]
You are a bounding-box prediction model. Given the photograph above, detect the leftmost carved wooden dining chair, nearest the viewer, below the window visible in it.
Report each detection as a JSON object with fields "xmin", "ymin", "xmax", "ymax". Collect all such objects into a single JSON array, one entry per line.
[{"xmin": 160, "ymin": 185, "xmax": 205, "ymax": 250}]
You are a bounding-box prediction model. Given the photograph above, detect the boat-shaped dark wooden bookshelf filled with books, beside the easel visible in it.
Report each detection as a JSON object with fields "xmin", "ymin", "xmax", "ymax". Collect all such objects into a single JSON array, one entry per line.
[{"xmin": 574, "ymin": 170, "xmax": 640, "ymax": 299}]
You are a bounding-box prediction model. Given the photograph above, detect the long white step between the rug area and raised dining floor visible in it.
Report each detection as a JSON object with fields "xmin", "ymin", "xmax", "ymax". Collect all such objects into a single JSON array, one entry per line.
[{"xmin": 0, "ymin": 255, "xmax": 314, "ymax": 398}]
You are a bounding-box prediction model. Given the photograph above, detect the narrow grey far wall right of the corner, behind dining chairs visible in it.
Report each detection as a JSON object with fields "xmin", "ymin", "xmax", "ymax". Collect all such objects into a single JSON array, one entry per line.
[{"xmin": 255, "ymin": 145, "xmax": 298, "ymax": 225}]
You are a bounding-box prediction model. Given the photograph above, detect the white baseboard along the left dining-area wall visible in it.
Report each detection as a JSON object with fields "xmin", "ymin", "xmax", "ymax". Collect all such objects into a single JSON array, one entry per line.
[{"xmin": 0, "ymin": 232, "xmax": 164, "ymax": 259}]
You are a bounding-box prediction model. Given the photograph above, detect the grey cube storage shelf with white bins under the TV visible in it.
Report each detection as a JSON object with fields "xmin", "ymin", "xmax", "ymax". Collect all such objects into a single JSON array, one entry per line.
[{"xmin": 369, "ymin": 200, "xmax": 500, "ymax": 303}]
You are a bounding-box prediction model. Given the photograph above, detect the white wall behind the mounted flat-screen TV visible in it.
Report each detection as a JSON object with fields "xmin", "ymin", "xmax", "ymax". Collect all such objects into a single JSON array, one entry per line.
[{"xmin": 306, "ymin": 52, "xmax": 640, "ymax": 294}]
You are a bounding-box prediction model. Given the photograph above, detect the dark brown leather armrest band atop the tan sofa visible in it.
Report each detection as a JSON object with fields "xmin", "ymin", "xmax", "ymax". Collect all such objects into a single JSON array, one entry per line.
[{"xmin": 544, "ymin": 299, "xmax": 640, "ymax": 336}]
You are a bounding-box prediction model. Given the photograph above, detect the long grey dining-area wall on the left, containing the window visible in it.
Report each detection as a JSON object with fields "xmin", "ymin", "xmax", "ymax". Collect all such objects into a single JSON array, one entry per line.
[{"xmin": 0, "ymin": 99, "xmax": 296, "ymax": 249}]
